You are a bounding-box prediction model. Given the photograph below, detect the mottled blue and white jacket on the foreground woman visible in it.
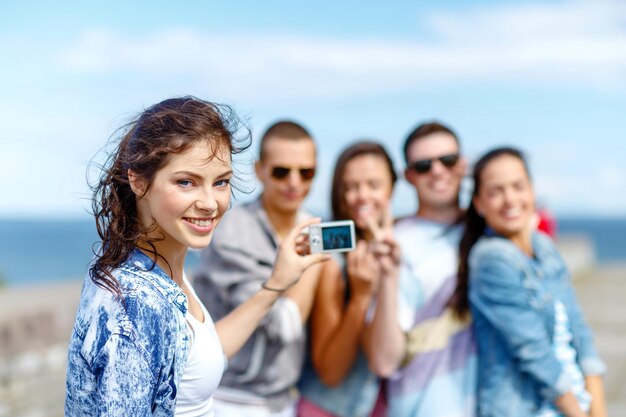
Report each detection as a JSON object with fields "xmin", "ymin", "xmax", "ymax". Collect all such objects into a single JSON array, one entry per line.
[{"xmin": 65, "ymin": 250, "xmax": 190, "ymax": 416}]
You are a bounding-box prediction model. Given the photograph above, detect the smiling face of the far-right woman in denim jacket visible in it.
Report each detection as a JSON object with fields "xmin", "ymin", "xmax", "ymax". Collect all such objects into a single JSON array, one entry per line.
[{"xmin": 473, "ymin": 155, "xmax": 535, "ymax": 239}]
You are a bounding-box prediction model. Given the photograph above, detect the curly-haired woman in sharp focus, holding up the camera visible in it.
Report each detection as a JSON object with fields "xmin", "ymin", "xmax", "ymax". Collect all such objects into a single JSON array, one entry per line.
[{"xmin": 65, "ymin": 97, "xmax": 327, "ymax": 417}]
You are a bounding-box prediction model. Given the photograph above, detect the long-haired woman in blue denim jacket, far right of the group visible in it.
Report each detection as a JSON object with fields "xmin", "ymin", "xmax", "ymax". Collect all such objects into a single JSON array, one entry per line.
[{"xmin": 453, "ymin": 148, "xmax": 606, "ymax": 417}]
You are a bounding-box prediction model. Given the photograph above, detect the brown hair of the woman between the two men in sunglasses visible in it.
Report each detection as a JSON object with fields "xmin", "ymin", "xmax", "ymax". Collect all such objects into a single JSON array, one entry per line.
[{"xmin": 331, "ymin": 141, "xmax": 398, "ymax": 237}]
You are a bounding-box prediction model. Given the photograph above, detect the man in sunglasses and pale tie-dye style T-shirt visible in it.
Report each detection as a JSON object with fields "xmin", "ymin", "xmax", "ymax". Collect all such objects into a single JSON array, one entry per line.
[{"xmin": 367, "ymin": 122, "xmax": 476, "ymax": 417}]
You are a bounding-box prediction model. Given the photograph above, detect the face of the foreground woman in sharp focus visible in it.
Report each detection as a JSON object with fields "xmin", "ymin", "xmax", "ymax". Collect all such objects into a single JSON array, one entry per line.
[{"xmin": 129, "ymin": 143, "xmax": 232, "ymax": 254}]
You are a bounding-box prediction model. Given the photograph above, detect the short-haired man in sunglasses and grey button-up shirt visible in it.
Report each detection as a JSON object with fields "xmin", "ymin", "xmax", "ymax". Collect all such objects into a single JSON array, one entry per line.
[{"xmin": 194, "ymin": 121, "xmax": 319, "ymax": 417}]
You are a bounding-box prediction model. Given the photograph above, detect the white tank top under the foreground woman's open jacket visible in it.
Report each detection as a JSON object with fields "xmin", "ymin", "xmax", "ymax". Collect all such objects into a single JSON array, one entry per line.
[{"xmin": 176, "ymin": 283, "xmax": 226, "ymax": 417}]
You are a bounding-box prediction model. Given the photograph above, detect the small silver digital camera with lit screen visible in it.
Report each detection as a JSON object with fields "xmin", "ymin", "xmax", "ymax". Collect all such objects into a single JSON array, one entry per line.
[{"xmin": 309, "ymin": 220, "xmax": 356, "ymax": 253}]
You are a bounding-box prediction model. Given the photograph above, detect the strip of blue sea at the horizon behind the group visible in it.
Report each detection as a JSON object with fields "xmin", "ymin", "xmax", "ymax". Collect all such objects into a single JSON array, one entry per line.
[{"xmin": 0, "ymin": 218, "xmax": 626, "ymax": 286}]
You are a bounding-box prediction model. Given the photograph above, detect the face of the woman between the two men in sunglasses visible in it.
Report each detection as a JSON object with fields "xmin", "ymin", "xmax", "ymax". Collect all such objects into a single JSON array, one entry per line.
[{"xmin": 342, "ymin": 154, "xmax": 393, "ymax": 229}]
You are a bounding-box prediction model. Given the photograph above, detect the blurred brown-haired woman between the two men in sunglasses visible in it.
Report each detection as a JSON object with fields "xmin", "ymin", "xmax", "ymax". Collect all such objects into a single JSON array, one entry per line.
[{"xmin": 298, "ymin": 142, "xmax": 399, "ymax": 417}]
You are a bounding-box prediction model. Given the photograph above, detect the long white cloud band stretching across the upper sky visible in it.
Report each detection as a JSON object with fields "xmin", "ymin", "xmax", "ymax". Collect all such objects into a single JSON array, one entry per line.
[{"xmin": 57, "ymin": 1, "xmax": 626, "ymax": 102}]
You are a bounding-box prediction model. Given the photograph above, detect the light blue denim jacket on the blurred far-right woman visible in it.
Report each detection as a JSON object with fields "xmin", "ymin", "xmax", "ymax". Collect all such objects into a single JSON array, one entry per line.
[{"xmin": 469, "ymin": 233, "xmax": 604, "ymax": 417}]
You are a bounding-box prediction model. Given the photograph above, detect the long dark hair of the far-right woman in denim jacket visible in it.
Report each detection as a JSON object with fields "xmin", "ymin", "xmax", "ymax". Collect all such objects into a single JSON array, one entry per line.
[{"xmin": 450, "ymin": 147, "xmax": 530, "ymax": 317}]
